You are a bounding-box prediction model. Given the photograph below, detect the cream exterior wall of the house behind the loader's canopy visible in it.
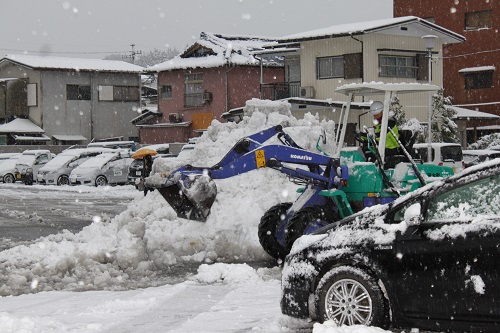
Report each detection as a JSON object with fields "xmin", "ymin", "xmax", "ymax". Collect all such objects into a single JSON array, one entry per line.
[{"xmin": 300, "ymin": 34, "xmax": 443, "ymax": 126}]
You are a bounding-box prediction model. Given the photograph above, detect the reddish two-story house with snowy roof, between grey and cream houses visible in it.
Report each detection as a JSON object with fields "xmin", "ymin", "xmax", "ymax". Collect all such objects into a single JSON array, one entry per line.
[{"xmin": 137, "ymin": 33, "xmax": 284, "ymax": 144}]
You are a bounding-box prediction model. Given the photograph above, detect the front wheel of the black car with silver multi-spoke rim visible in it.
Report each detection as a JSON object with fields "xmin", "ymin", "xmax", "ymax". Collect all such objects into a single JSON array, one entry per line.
[{"xmin": 315, "ymin": 266, "xmax": 388, "ymax": 327}]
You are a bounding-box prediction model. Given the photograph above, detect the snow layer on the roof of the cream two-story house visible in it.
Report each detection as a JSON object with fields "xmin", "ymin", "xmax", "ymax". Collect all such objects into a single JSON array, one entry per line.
[{"xmin": 278, "ymin": 16, "xmax": 465, "ymax": 43}]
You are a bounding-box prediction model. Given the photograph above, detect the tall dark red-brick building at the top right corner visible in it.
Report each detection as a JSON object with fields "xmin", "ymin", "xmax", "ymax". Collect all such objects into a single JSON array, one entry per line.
[{"xmin": 394, "ymin": 0, "xmax": 500, "ymax": 142}]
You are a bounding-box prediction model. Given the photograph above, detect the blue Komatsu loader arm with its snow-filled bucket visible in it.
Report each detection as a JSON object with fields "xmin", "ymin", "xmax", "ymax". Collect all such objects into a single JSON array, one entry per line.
[{"xmin": 152, "ymin": 126, "xmax": 348, "ymax": 221}]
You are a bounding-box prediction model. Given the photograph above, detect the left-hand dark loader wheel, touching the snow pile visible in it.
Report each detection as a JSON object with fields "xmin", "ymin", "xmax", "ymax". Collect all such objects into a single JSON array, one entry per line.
[{"xmin": 258, "ymin": 202, "xmax": 292, "ymax": 259}]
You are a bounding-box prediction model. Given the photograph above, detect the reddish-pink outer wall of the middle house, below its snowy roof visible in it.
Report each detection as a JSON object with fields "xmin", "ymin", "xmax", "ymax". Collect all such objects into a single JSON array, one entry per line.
[{"xmin": 146, "ymin": 66, "xmax": 284, "ymax": 143}]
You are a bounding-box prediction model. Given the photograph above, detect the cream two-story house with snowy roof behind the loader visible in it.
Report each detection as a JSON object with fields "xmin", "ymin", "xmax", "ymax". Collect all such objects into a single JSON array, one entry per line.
[{"xmin": 263, "ymin": 16, "xmax": 464, "ymax": 143}]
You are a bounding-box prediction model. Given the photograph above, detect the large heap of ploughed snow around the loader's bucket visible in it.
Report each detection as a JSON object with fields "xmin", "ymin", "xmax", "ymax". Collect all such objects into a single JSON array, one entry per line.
[{"xmin": 0, "ymin": 102, "xmax": 334, "ymax": 295}]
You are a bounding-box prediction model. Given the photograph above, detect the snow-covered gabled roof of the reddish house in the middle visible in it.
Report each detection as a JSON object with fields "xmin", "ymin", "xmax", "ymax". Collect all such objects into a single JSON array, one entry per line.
[{"xmin": 148, "ymin": 32, "xmax": 282, "ymax": 72}]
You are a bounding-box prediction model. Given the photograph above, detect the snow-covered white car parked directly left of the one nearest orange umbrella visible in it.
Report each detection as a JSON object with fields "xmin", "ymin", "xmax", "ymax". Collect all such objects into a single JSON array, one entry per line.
[{"xmin": 37, "ymin": 147, "xmax": 113, "ymax": 185}]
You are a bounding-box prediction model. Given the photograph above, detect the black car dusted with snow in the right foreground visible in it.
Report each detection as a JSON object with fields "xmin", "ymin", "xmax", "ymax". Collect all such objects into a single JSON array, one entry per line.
[{"xmin": 281, "ymin": 159, "xmax": 500, "ymax": 332}]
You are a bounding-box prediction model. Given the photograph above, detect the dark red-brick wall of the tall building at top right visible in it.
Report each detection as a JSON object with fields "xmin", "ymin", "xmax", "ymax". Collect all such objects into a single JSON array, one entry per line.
[{"xmin": 394, "ymin": 0, "xmax": 500, "ymax": 125}]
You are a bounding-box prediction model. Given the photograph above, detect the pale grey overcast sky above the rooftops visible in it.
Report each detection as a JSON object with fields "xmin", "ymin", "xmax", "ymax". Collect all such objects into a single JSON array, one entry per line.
[{"xmin": 0, "ymin": 0, "xmax": 393, "ymax": 59}]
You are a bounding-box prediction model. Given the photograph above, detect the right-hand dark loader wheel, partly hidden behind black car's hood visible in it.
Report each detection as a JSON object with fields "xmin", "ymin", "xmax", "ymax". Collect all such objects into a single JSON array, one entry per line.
[{"xmin": 285, "ymin": 206, "xmax": 340, "ymax": 253}]
